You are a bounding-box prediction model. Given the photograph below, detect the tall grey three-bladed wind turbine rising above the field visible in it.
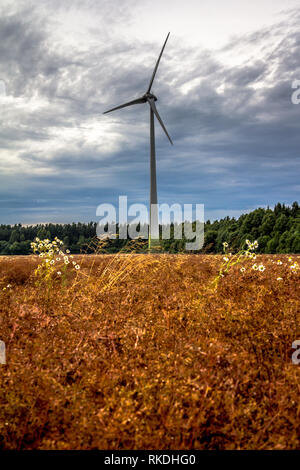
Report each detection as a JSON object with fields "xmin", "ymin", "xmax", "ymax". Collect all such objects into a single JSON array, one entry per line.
[{"xmin": 103, "ymin": 33, "xmax": 173, "ymax": 250}]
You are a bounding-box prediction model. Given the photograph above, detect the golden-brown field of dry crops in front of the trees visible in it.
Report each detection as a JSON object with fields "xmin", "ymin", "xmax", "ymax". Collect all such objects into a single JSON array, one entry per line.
[{"xmin": 0, "ymin": 254, "xmax": 300, "ymax": 449}]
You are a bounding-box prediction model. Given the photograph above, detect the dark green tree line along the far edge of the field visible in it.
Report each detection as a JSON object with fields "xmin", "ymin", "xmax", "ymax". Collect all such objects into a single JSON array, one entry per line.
[{"xmin": 0, "ymin": 202, "xmax": 300, "ymax": 255}]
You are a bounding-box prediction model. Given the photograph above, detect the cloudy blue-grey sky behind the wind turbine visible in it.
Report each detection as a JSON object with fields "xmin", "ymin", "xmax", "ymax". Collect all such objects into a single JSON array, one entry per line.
[{"xmin": 0, "ymin": 0, "xmax": 300, "ymax": 224}]
